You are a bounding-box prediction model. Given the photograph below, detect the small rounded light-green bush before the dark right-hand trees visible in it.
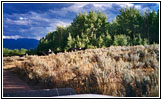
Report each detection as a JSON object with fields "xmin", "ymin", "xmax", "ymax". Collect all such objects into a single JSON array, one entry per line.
[{"xmin": 113, "ymin": 35, "xmax": 128, "ymax": 46}]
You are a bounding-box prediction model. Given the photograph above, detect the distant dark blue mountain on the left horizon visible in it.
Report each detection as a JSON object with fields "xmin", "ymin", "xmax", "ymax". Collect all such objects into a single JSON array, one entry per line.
[{"xmin": 3, "ymin": 38, "xmax": 39, "ymax": 50}]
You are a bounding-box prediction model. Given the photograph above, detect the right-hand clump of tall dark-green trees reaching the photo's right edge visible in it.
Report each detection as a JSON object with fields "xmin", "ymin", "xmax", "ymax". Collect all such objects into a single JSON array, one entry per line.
[{"xmin": 112, "ymin": 7, "xmax": 159, "ymax": 45}]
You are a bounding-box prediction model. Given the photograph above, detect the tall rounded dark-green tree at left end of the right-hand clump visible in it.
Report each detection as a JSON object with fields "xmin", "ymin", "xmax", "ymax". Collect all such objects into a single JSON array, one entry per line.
[{"xmin": 116, "ymin": 7, "xmax": 141, "ymax": 43}]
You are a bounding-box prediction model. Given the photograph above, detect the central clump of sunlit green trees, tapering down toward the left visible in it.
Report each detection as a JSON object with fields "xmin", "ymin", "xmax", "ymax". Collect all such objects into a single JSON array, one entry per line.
[{"xmin": 37, "ymin": 11, "xmax": 111, "ymax": 51}]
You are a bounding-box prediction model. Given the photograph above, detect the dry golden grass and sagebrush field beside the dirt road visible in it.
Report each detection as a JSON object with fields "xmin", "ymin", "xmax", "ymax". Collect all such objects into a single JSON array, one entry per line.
[{"xmin": 3, "ymin": 45, "xmax": 159, "ymax": 97}]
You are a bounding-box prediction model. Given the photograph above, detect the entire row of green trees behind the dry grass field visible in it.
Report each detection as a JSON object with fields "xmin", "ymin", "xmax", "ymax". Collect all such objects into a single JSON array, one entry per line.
[{"xmin": 3, "ymin": 7, "xmax": 159, "ymax": 54}]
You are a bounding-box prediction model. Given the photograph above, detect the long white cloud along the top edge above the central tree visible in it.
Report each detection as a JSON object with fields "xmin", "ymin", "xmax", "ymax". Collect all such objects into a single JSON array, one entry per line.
[{"xmin": 49, "ymin": 2, "xmax": 135, "ymax": 16}]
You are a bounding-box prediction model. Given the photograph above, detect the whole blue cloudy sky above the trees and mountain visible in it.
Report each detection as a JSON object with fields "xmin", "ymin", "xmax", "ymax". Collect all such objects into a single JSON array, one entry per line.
[{"xmin": 3, "ymin": 2, "xmax": 159, "ymax": 40}]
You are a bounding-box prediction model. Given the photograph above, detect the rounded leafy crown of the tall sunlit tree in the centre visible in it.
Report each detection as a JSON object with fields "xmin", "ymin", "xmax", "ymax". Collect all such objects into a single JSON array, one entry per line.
[{"xmin": 71, "ymin": 11, "xmax": 108, "ymax": 37}]
